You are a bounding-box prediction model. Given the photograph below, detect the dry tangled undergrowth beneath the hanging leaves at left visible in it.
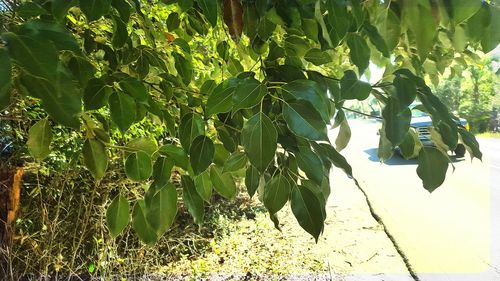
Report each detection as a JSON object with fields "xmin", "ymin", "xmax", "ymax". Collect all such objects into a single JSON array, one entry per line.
[{"xmin": 0, "ymin": 103, "xmax": 264, "ymax": 281}]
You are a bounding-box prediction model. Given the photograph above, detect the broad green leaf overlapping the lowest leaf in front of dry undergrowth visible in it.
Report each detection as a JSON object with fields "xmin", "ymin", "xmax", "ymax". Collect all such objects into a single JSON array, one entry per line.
[{"xmin": 146, "ymin": 183, "xmax": 177, "ymax": 237}]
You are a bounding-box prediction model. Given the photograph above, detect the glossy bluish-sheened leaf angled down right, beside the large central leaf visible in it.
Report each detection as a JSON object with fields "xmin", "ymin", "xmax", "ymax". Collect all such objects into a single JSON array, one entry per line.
[{"xmin": 283, "ymin": 100, "xmax": 328, "ymax": 140}]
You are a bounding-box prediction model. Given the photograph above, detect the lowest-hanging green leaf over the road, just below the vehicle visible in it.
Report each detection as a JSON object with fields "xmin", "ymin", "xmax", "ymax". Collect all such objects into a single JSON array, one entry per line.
[{"xmin": 417, "ymin": 147, "xmax": 448, "ymax": 192}]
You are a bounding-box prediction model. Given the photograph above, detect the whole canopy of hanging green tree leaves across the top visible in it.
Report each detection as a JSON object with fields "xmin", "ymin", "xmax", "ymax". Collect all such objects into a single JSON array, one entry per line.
[{"xmin": 0, "ymin": 0, "xmax": 500, "ymax": 244}]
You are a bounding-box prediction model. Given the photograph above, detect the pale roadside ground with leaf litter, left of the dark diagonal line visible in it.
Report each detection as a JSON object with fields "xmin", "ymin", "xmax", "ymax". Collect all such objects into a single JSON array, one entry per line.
[{"xmin": 161, "ymin": 167, "xmax": 411, "ymax": 280}]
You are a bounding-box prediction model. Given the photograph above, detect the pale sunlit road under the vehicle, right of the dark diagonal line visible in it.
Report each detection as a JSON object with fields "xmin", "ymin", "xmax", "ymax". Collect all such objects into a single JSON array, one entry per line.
[{"xmin": 330, "ymin": 120, "xmax": 500, "ymax": 281}]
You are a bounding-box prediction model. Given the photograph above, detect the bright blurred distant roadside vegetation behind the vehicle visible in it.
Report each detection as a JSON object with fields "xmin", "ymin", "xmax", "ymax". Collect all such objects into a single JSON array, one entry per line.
[{"xmin": 346, "ymin": 55, "xmax": 500, "ymax": 134}]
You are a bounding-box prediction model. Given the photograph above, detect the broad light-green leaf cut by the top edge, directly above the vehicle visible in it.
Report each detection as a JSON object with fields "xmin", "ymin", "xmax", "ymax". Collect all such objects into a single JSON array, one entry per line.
[{"xmin": 402, "ymin": 1, "xmax": 437, "ymax": 61}]
